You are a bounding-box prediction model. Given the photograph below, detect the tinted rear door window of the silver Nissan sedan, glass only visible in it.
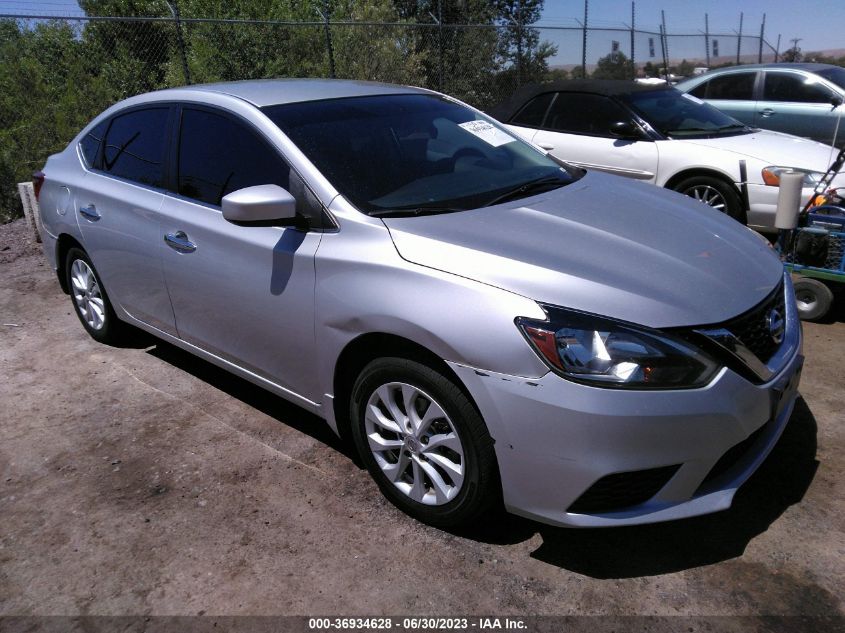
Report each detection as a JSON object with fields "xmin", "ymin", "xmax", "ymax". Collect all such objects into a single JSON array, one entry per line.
[{"xmin": 102, "ymin": 108, "xmax": 169, "ymax": 188}]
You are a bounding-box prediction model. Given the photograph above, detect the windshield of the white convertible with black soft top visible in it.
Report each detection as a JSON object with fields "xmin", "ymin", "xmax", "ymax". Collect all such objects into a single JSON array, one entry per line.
[{"xmin": 622, "ymin": 89, "xmax": 748, "ymax": 138}]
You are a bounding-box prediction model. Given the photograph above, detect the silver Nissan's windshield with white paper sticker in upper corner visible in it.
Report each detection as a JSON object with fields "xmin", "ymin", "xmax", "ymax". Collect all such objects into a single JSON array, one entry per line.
[{"xmin": 263, "ymin": 94, "xmax": 575, "ymax": 215}]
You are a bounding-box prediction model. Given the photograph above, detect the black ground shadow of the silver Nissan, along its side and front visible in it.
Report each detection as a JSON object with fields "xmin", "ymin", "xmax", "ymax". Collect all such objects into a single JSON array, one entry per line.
[{"xmin": 137, "ymin": 341, "xmax": 818, "ymax": 578}]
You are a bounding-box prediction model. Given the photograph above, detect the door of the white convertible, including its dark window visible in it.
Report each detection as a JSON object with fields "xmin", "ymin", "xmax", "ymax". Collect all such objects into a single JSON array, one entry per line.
[{"xmin": 533, "ymin": 92, "xmax": 658, "ymax": 183}]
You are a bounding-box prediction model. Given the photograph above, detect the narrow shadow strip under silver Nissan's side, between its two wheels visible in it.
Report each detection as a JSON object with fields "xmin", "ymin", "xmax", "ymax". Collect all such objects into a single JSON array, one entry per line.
[{"xmin": 147, "ymin": 340, "xmax": 360, "ymax": 460}]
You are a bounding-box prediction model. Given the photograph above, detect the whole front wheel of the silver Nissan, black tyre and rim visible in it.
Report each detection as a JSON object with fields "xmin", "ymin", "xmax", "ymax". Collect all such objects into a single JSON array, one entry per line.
[{"xmin": 350, "ymin": 358, "xmax": 500, "ymax": 527}]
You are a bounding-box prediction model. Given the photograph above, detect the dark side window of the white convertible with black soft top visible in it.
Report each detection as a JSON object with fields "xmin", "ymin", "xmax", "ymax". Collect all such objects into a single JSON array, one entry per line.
[{"xmin": 544, "ymin": 92, "xmax": 631, "ymax": 136}]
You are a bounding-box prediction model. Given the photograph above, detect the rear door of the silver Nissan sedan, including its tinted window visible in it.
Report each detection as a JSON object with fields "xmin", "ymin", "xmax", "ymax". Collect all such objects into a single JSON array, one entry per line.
[{"xmin": 76, "ymin": 104, "xmax": 175, "ymax": 334}]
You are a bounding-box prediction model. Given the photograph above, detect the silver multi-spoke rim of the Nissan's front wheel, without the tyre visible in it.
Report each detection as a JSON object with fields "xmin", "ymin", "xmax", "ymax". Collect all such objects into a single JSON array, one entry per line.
[{"xmin": 364, "ymin": 382, "xmax": 466, "ymax": 505}]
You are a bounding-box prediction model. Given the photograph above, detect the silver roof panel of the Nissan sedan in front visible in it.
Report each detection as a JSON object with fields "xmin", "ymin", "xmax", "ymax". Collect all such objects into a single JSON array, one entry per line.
[{"xmin": 150, "ymin": 79, "xmax": 430, "ymax": 108}]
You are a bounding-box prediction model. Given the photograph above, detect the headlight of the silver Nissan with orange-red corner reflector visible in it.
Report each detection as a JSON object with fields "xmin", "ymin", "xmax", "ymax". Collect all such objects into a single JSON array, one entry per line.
[{"xmin": 516, "ymin": 305, "xmax": 719, "ymax": 389}]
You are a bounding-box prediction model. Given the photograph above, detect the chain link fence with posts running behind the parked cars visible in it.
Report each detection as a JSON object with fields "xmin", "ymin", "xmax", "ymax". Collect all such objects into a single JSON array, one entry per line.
[{"xmin": 0, "ymin": 16, "xmax": 775, "ymax": 222}]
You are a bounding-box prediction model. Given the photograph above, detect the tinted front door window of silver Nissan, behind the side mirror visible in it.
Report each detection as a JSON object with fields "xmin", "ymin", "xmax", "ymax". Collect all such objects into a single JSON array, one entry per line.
[{"xmin": 179, "ymin": 108, "xmax": 290, "ymax": 205}]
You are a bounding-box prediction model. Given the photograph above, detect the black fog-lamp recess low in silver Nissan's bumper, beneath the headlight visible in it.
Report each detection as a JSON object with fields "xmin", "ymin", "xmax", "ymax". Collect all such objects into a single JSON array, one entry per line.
[{"xmin": 566, "ymin": 464, "xmax": 681, "ymax": 514}]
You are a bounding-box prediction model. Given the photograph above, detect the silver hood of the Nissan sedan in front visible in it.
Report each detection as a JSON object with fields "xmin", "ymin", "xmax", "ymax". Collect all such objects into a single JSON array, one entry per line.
[{"xmin": 384, "ymin": 172, "xmax": 783, "ymax": 327}]
